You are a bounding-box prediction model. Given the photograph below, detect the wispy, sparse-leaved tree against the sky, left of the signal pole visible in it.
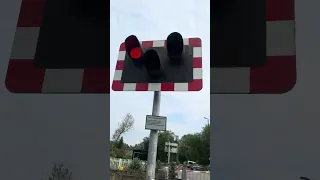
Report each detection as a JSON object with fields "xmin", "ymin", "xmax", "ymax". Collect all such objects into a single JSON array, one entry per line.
[{"xmin": 112, "ymin": 113, "xmax": 134, "ymax": 142}]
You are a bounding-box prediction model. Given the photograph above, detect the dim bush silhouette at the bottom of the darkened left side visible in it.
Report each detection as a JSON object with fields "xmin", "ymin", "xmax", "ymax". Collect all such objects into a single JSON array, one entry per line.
[{"xmin": 42, "ymin": 163, "xmax": 72, "ymax": 180}]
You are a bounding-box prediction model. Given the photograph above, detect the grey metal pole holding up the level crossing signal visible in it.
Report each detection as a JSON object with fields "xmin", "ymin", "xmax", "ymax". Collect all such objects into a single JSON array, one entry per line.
[{"xmin": 146, "ymin": 91, "xmax": 161, "ymax": 180}]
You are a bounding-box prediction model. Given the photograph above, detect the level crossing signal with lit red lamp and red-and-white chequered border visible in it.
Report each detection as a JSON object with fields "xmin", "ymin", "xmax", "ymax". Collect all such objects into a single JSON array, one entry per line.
[{"xmin": 112, "ymin": 32, "xmax": 202, "ymax": 91}]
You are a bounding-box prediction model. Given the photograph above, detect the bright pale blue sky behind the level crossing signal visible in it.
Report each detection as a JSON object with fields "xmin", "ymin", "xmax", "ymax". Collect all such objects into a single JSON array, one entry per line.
[{"xmin": 110, "ymin": 0, "xmax": 210, "ymax": 145}]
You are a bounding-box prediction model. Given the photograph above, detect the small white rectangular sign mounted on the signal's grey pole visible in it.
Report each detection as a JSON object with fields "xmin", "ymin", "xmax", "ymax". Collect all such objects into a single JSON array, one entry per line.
[{"xmin": 145, "ymin": 115, "xmax": 167, "ymax": 131}]
